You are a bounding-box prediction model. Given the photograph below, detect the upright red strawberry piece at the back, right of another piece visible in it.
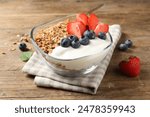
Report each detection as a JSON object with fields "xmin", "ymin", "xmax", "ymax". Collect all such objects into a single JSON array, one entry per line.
[{"xmin": 88, "ymin": 13, "xmax": 99, "ymax": 30}]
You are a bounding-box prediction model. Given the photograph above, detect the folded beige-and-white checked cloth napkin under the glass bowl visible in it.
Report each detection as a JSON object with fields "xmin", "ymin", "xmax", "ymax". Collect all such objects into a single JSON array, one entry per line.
[{"xmin": 22, "ymin": 24, "xmax": 121, "ymax": 94}]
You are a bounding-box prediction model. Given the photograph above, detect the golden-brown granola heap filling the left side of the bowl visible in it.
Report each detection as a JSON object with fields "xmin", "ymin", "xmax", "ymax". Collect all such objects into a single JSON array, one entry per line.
[{"xmin": 35, "ymin": 20, "xmax": 68, "ymax": 53}]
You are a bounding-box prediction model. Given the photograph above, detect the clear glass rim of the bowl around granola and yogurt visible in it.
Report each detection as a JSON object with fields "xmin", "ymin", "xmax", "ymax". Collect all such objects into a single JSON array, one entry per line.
[{"xmin": 30, "ymin": 14, "xmax": 113, "ymax": 61}]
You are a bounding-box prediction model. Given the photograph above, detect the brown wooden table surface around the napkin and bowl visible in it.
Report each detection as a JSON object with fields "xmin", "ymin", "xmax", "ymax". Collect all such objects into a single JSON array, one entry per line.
[{"xmin": 0, "ymin": 0, "xmax": 150, "ymax": 99}]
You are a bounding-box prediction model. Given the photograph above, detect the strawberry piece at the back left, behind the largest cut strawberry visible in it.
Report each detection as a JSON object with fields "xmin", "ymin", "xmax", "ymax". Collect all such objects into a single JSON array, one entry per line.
[{"xmin": 76, "ymin": 13, "xmax": 88, "ymax": 26}]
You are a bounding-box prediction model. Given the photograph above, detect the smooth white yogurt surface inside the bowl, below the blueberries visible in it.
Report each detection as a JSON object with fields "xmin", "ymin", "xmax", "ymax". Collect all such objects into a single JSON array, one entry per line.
[{"xmin": 50, "ymin": 37, "xmax": 110, "ymax": 60}]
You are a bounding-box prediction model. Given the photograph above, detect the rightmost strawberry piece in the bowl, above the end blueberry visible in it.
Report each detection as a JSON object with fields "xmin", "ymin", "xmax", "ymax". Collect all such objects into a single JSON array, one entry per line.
[{"xmin": 94, "ymin": 23, "xmax": 109, "ymax": 35}]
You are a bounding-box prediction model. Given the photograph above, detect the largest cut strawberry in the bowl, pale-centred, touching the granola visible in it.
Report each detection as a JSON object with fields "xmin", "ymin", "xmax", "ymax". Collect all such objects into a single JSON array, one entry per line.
[{"xmin": 67, "ymin": 21, "xmax": 86, "ymax": 38}]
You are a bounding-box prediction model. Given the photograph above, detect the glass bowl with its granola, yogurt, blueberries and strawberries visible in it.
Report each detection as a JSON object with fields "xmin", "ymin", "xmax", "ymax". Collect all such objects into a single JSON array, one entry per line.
[{"xmin": 31, "ymin": 13, "xmax": 113, "ymax": 77}]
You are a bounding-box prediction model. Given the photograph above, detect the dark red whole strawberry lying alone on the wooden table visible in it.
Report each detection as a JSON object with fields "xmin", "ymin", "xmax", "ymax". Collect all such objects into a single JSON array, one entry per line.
[{"xmin": 119, "ymin": 56, "xmax": 140, "ymax": 77}]
